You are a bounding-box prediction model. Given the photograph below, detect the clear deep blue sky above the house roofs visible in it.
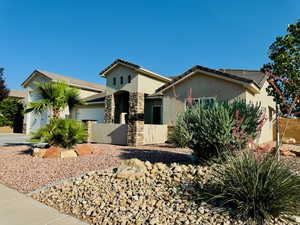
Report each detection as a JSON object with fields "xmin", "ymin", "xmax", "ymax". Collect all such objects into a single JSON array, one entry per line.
[{"xmin": 0, "ymin": 0, "xmax": 300, "ymax": 89}]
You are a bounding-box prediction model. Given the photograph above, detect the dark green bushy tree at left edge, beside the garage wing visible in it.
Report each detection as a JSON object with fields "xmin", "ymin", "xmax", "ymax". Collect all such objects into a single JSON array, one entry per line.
[{"xmin": 0, "ymin": 97, "xmax": 24, "ymax": 133}]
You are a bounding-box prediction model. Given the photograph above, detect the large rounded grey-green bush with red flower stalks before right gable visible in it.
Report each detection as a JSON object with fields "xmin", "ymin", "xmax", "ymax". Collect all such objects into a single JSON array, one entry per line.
[{"xmin": 171, "ymin": 100, "xmax": 264, "ymax": 160}]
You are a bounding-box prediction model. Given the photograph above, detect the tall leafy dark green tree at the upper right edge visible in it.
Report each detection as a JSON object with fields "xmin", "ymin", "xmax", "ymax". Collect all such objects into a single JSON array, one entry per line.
[{"xmin": 263, "ymin": 19, "xmax": 300, "ymax": 114}]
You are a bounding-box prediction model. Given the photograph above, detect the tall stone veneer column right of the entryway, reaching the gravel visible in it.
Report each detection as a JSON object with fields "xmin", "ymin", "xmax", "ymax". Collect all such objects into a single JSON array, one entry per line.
[{"xmin": 127, "ymin": 92, "xmax": 144, "ymax": 146}]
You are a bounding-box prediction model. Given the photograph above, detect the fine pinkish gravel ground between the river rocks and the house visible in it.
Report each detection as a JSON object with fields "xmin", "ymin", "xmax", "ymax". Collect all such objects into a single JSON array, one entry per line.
[{"xmin": 0, "ymin": 144, "xmax": 191, "ymax": 193}]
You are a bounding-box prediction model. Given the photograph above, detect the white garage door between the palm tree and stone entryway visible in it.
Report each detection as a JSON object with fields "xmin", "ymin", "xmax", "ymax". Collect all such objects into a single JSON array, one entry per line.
[{"xmin": 76, "ymin": 107, "xmax": 104, "ymax": 123}]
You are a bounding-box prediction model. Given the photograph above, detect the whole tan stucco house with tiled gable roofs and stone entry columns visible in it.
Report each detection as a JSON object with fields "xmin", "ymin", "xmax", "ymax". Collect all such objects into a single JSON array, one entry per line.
[{"xmin": 23, "ymin": 59, "xmax": 275, "ymax": 145}]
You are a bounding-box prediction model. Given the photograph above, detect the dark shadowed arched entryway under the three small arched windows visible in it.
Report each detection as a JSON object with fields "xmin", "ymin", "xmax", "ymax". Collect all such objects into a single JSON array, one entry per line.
[{"xmin": 114, "ymin": 91, "xmax": 129, "ymax": 123}]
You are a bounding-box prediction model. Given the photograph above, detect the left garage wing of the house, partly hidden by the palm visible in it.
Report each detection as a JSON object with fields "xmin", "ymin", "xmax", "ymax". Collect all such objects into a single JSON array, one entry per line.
[{"xmin": 22, "ymin": 70, "xmax": 105, "ymax": 134}]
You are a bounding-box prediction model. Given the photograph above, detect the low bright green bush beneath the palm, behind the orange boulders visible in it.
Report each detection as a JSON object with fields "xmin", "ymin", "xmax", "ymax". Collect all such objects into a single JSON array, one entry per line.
[{"xmin": 32, "ymin": 119, "xmax": 87, "ymax": 148}]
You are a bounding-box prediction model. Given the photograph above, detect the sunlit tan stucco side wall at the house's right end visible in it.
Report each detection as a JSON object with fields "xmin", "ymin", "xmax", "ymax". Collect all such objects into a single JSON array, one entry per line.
[{"xmin": 246, "ymin": 81, "xmax": 276, "ymax": 144}]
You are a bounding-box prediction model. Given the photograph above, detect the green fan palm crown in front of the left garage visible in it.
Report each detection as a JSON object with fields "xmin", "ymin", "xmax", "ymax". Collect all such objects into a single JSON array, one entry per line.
[{"xmin": 25, "ymin": 82, "xmax": 84, "ymax": 119}]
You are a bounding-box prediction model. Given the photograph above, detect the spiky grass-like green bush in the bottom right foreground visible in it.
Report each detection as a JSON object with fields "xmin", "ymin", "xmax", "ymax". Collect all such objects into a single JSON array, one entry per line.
[{"xmin": 206, "ymin": 152, "xmax": 300, "ymax": 224}]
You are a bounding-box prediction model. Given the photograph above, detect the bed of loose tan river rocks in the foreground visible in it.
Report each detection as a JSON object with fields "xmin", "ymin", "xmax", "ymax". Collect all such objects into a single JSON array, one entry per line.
[{"xmin": 31, "ymin": 162, "xmax": 298, "ymax": 225}]
